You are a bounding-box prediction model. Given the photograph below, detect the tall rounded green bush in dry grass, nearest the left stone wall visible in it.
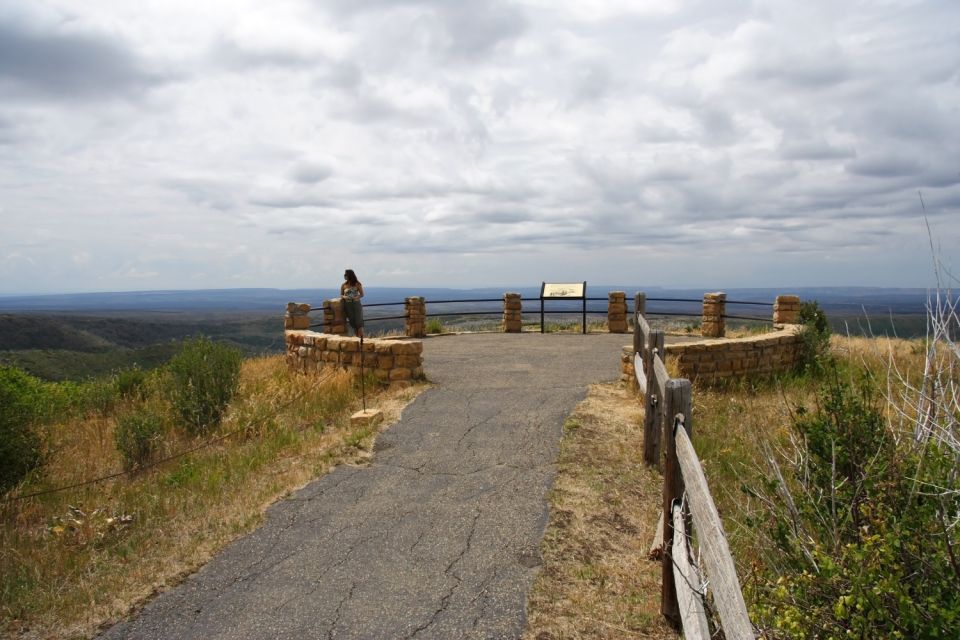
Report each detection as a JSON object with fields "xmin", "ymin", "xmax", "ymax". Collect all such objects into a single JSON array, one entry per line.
[{"xmin": 167, "ymin": 336, "xmax": 243, "ymax": 434}]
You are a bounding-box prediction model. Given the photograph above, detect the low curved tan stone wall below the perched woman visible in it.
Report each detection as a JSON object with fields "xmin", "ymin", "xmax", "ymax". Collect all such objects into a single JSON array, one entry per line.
[{"xmin": 284, "ymin": 329, "xmax": 423, "ymax": 387}]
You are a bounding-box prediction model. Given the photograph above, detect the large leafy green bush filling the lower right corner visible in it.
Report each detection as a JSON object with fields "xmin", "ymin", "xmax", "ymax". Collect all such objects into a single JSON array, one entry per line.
[{"xmin": 747, "ymin": 369, "xmax": 960, "ymax": 638}]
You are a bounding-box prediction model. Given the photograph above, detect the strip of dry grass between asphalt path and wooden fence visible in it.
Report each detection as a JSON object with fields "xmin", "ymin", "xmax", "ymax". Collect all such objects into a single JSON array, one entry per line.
[{"xmin": 523, "ymin": 384, "xmax": 677, "ymax": 640}]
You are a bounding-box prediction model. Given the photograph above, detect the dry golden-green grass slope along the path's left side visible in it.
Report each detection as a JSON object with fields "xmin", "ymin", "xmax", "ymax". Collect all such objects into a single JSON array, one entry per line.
[{"xmin": 0, "ymin": 356, "xmax": 423, "ymax": 638}]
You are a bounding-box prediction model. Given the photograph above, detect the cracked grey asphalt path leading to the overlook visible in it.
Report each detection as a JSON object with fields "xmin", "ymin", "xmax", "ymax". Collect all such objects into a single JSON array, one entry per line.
[{"xmin": 100, "ymin": 333, "xmax": 631, "ymax": 640}]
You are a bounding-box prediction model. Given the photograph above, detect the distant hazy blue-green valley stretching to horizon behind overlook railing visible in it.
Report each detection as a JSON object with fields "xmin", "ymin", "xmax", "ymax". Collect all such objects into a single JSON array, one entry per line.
[{"xmin": 0, "ymin": 284, "xmax": 927, "ymax": 380}]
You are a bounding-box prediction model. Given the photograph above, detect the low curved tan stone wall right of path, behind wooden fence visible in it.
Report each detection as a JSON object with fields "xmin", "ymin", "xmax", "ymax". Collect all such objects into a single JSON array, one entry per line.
[{"xmin": 620, "ymin": 324, "xmax": 801, "ymax": 388}]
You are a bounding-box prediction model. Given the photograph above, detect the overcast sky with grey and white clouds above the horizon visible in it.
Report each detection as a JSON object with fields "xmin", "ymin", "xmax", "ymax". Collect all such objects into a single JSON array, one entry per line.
[{"xmin": 0, "ymin": 0, "xmax": 960, "ymax": 293}]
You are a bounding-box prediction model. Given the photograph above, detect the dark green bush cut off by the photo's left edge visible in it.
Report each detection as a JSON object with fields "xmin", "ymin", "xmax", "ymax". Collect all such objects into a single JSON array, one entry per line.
[{"xmin": 0, "ymin": 366, "xmax": 43, "ymax": 493}]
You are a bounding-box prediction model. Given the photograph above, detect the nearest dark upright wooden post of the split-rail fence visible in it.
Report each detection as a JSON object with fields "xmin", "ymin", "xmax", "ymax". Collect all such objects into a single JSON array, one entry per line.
[{"xmin": 660, "ymin": 378, "xmax": 693, "ymax": 627}]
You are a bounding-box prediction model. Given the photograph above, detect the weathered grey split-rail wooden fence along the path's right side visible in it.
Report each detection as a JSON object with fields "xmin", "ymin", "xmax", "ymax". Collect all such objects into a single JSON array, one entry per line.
[{"xmin": 633, "ymin": 293, "xmax": 756, "ymax": 640}]
